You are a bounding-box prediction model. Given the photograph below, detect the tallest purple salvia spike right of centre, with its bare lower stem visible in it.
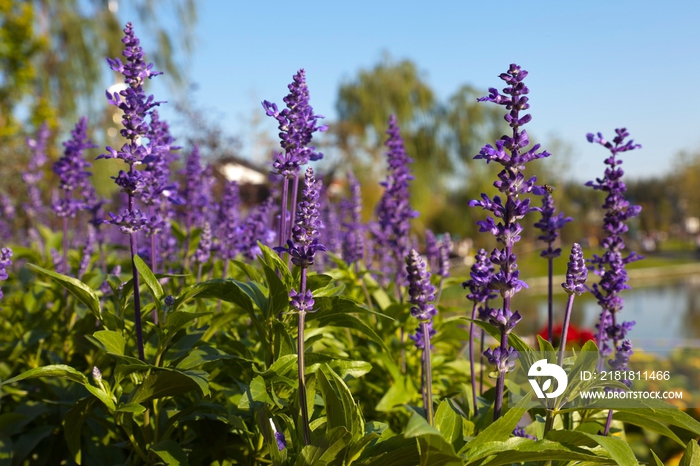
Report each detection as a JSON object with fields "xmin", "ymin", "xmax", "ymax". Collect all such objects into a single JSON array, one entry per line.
[{"xmin": 469, "ymin": 64, "xmax": 550, "ymax": 419}]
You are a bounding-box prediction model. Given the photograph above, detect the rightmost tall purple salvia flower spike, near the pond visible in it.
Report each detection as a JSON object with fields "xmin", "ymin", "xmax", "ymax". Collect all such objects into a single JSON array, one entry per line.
[{"xmin": 586, "ymin": 128, "xmax": 643, "ymax": 356}]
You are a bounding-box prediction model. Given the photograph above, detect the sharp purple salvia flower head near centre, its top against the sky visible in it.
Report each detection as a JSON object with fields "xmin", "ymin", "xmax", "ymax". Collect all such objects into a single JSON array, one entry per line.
[{"xmin": 262, "ymin": 69, "xmax": 328, "ymax": 177}]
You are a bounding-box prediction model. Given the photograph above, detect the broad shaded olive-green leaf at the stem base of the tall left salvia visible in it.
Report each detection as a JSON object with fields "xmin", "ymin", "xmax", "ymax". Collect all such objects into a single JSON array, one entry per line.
[{"xmin": 129, "ymin": 370, "xmax": 209, "ymax": 403}]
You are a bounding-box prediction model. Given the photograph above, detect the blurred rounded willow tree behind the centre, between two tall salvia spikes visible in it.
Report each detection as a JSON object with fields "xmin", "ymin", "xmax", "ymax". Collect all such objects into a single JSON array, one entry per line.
[{"xmin": 330, "ymin": 54, "xmax": 506, "ymax": 234}]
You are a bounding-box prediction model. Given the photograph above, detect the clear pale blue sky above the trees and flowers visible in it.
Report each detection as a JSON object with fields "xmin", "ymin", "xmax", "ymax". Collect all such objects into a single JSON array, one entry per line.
[{"xmin": 129, "ymin": 0, "xmax": 700, "ymax": 180}]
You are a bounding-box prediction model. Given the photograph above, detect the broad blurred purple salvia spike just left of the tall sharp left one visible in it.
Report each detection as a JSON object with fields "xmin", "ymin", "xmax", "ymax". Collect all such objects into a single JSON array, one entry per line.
[{"xmin": 53, "ymin": 117, "xmax": 97, "ymax": 217}]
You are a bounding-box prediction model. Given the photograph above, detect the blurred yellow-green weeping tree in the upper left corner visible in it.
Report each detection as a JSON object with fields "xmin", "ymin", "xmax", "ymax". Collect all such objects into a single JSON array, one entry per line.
[{"xmin": 0, "ymin": 0, "xmax": 196, "ymax": 204}]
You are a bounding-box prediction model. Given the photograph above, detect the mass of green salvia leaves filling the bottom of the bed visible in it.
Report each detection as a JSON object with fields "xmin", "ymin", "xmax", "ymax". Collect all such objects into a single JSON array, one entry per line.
[{"xmin": 0, "ymin": 225, "xmax": 700, "ymax": 466}]
